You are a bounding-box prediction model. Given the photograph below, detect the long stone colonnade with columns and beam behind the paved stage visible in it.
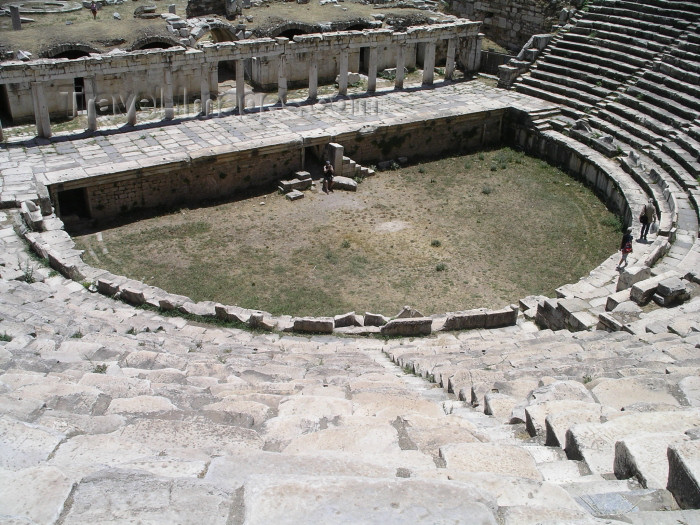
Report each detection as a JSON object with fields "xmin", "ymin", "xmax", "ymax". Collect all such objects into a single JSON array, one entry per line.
[{"xmin": 0, "ymin": 22, "xmax": 482, "ymax": 139}]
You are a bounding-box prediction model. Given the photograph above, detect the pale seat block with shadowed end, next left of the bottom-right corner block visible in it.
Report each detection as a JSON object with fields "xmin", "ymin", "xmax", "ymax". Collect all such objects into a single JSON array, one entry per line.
[{"xmin": 614, "ymin": 432, "xmax": 690, "ymax": 489}]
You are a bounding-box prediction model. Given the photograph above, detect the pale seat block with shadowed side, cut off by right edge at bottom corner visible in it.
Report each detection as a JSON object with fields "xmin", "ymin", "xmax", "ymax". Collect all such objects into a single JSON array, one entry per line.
[{"xmin": 668, "ymin": 441, "xmax": 700, "ymax": 509}]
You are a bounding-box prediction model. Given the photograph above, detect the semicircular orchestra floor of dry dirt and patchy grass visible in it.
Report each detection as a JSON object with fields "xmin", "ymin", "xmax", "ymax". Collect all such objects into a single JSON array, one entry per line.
[{"xmin": 76, "ymin": 150, "xmax": 618, "ymax": 315}]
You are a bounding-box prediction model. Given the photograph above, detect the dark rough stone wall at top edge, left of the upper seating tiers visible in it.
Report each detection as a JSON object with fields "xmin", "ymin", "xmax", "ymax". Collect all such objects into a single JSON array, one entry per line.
[{"xmin": 449, "ymin": 0, "xmax": 583, "ymax": 51}]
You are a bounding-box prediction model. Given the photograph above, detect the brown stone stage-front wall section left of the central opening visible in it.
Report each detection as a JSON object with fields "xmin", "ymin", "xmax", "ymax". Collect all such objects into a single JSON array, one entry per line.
[{"xmin": 72, "ymin": 141, "xmax": 302, "ymax": 219}]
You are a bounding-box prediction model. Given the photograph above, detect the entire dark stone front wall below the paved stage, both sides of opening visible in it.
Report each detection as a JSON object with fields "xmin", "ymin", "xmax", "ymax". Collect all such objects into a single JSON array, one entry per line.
[{"xmin": 49, "ymin": 108, "xmax": 505, "ymax": 219}]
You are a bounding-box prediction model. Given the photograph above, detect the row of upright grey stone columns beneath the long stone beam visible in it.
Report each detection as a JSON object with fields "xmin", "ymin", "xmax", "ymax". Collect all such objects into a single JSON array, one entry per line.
[{"xmin": 24, "ymin": 38, "xmax": 457, "ymax": 140}]
